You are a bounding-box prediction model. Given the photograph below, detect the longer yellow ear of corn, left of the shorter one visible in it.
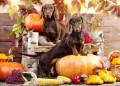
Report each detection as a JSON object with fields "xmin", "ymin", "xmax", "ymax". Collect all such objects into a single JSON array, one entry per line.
[{"xmin": 37, "ymin": 78, "xmax": 64, "ymax": 85}]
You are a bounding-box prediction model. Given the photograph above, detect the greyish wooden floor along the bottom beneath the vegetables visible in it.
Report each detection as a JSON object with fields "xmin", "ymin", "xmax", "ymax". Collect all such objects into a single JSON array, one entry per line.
[{"xmin": 0, "ymin": 82, "xmax": 120, "ymax": 86}]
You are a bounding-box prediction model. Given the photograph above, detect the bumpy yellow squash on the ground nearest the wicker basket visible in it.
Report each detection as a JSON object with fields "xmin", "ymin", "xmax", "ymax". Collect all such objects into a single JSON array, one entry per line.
[{"xmin": 98, "ymin": 70, "xmax": 116, "ymax": 83}]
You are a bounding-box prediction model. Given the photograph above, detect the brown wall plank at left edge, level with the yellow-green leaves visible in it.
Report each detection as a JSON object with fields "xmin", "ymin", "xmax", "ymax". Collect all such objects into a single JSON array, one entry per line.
[{"xmin": 0, "ymin": 26, "xmax": 13, "ymax": 41}]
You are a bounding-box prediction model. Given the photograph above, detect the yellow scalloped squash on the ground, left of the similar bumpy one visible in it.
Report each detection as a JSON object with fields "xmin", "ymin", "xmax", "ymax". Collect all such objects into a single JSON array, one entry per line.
[{"xmin": 85, "ymin": 75, "xmax": 104, "ymax": 84}]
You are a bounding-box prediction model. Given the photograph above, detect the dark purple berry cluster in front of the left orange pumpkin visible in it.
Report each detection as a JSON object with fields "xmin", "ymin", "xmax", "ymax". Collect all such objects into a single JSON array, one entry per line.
[{"xmin": 5, "ymin": 69, "xmax": 24, "ymax": 84}]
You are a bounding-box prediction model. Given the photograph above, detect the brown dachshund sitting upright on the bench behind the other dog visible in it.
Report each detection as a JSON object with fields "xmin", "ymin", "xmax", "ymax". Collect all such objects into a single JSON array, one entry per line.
[{"xmin": 40, "ymin": 4, "xmax": 65, "ymax": 44}]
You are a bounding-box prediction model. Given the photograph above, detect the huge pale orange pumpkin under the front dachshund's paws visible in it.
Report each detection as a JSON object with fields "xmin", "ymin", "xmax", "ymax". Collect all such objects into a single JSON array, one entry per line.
[{"xmin": 56, "ymin": 54, "xmax": 102, "ymax": 78}]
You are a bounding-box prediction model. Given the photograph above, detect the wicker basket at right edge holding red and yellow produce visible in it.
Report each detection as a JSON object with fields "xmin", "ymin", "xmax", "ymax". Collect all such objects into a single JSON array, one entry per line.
[{"xmin": 108, "ymin": 51, "xmax": 120, "ymax": 81}]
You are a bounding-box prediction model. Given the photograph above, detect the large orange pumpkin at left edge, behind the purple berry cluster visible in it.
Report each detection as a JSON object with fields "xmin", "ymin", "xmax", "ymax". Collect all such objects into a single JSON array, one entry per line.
[{"xmin": 0, "ymin": 62, "xmax": 24, "ymax": 81}]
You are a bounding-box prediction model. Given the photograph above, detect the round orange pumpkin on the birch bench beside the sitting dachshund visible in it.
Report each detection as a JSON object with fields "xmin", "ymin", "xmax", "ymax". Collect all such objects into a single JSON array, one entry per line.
[{"xmin": 25, "ymin": 13, "xmax": 44, "ymax": 33}]
